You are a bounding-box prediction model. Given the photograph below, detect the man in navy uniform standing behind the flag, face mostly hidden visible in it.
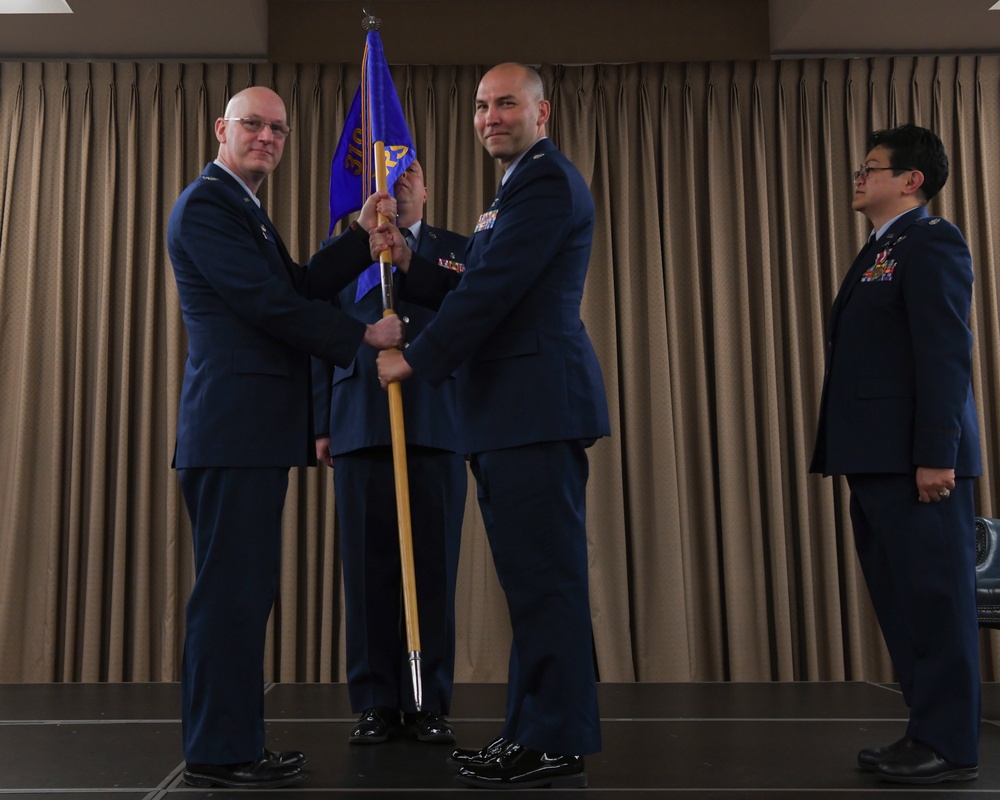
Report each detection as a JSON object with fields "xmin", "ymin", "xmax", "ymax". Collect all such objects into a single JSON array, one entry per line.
[{"xmin": 313, "ymin": 160, "xmax": 467, "ymax": 744}]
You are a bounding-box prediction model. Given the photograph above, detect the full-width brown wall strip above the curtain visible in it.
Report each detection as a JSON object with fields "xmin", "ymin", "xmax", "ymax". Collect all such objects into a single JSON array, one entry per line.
[{"xmin": 0, "ymin": 0, "xmax": 1000, "ymax": 64}]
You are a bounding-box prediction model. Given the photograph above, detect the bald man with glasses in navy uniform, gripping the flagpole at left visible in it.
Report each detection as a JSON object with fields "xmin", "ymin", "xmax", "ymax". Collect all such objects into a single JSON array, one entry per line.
[{"xmin": 167, "ymin": 86, "xmax": 403, "ymax": 788}]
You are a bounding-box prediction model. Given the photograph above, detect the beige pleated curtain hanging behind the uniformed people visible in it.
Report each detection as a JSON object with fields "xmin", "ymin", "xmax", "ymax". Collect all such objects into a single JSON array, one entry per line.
[{"xmin": 0, "ymin": 56, "xmax": 1000, "ymax": 682}]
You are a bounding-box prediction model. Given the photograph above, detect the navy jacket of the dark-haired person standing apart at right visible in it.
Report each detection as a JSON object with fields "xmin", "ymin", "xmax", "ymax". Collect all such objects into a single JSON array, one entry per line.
[{"xmin": 811, "ymin": 206, "xmax": 981, "ymax": 477}]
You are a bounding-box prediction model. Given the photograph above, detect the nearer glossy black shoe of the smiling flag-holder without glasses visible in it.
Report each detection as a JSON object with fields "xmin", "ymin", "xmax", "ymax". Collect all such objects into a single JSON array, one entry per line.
[{"xmin": 455, "ymin": 743, "xmax": 587, "ymax": 789}]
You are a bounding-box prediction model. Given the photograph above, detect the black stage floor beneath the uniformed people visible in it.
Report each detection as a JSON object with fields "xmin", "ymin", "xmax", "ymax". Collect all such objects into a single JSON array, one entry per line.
[{"xmin": 0, "ymin": 683, "xmax": 1000, "ymax": 800}]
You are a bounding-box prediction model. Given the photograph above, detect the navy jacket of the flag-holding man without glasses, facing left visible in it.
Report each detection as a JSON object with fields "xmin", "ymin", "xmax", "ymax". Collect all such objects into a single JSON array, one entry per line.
[{"xmin": 404, "ymin": 138, "xmax": 610, "ymax": 453}]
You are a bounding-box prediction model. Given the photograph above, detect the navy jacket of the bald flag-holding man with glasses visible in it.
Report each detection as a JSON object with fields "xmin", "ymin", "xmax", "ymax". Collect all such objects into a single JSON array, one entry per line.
[{"xmin": 167, "ymin": 163, "xmax": 374, "ymax": 468}]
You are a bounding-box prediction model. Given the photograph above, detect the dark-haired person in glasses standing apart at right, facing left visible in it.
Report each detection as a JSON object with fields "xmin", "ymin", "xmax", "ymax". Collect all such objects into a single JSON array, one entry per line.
[{"xmin": 811, "ymin": 125, "xmax": 981, "ymax": 783}]
